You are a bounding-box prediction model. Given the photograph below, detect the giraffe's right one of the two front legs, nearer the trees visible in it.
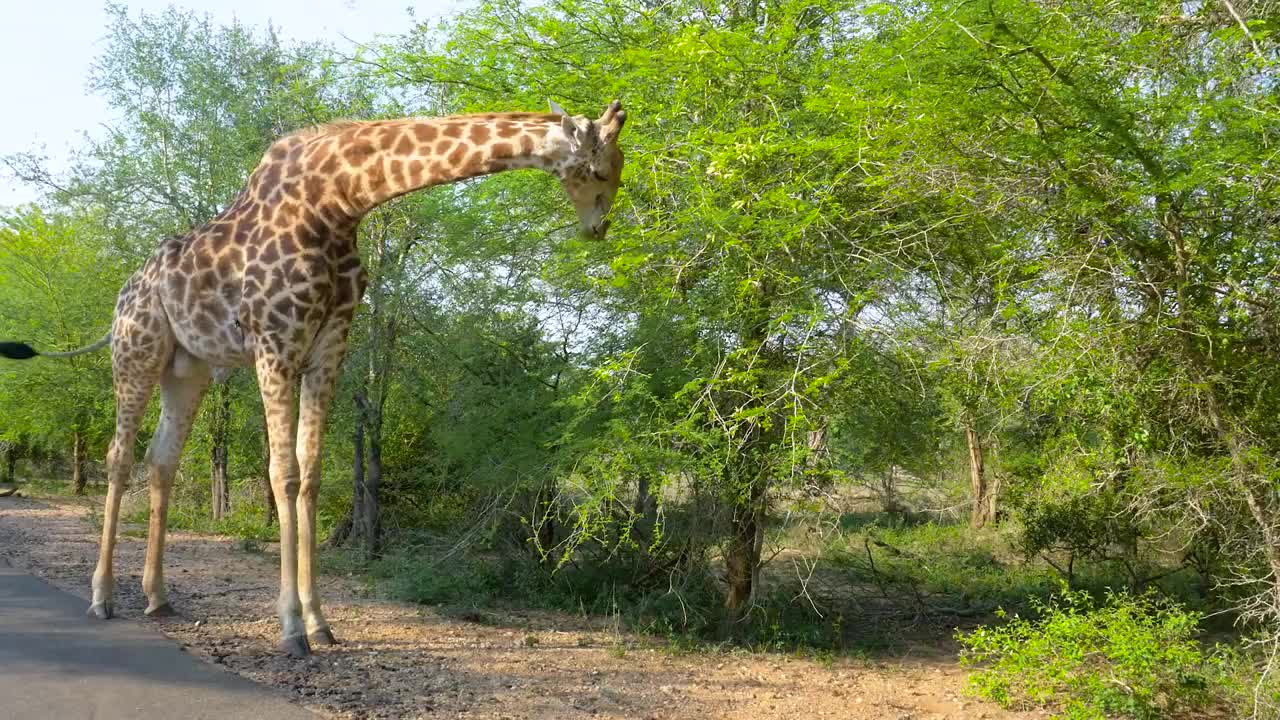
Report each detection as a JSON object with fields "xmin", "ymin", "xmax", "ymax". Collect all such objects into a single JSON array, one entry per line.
[{"xmin": 298, "ymin": 364, "xmax": 337, "ymax": 644}]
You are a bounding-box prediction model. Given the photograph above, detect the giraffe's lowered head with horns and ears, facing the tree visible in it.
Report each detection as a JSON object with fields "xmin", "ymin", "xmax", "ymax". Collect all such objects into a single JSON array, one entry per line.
[{"xmin": 550, "ymin": 100, "xmax": 627, "ymax": 240}]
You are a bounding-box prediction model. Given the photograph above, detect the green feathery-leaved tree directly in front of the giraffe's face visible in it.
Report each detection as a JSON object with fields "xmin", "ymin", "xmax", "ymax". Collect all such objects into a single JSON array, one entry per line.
[{"xmin": 381, "ymin": 3, "xmax": 967, "ymax": 628}]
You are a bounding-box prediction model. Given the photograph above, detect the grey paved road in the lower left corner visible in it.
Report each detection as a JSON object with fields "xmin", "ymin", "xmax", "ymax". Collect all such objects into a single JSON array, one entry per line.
[{"xmin": 0, "ymin": 559, "xmax": 319, "ymax": 720}]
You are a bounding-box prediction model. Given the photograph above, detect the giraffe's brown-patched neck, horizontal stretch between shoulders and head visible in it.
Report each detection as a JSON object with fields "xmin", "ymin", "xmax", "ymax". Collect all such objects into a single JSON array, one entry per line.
[{"xmin": 317, "ymin": 113, "xmax": 568, "ymax": 219}]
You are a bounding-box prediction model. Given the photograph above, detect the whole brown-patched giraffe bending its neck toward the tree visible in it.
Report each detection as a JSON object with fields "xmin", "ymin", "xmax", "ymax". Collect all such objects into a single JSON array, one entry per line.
[{"xmin": 0, "ymin": 100, "xmax": 626, "ymax": 657}]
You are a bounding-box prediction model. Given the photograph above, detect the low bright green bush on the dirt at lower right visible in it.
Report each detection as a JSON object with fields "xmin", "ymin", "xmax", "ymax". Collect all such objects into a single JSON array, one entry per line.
[{"xmin": 957, "ymin": 587, "xmax": 1242, "ymax": 720}]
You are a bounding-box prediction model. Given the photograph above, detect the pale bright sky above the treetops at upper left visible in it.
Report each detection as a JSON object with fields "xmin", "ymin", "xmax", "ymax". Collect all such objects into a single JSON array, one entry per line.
[{"xmin": 0, "ymin": 0, "xmax": 465, "ymax": 206}]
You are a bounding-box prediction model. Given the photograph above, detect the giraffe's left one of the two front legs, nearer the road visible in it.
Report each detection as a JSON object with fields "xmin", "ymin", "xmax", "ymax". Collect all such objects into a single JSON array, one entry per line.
[{"xmin": 257, "ymin": 355, "xmax": 311, "ymax": 657}]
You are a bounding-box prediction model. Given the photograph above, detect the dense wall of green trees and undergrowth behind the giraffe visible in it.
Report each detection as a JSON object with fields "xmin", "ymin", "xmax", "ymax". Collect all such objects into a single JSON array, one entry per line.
[{"xmin": 0, "ymin": 0, "xmax": 1280, "ymax": 702}]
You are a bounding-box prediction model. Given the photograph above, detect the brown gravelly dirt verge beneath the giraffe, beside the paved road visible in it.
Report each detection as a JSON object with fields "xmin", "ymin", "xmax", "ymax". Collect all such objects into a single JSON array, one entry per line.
[{"xmin": 0, "ymin": 497, "xmax": 1044, "ymax": 720}]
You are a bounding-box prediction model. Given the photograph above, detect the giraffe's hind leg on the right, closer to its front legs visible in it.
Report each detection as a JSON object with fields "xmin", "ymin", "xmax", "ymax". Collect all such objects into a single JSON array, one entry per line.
[{"xmin": 142, "ymin": 361, "xmax": 210, "ymax": 616}]
